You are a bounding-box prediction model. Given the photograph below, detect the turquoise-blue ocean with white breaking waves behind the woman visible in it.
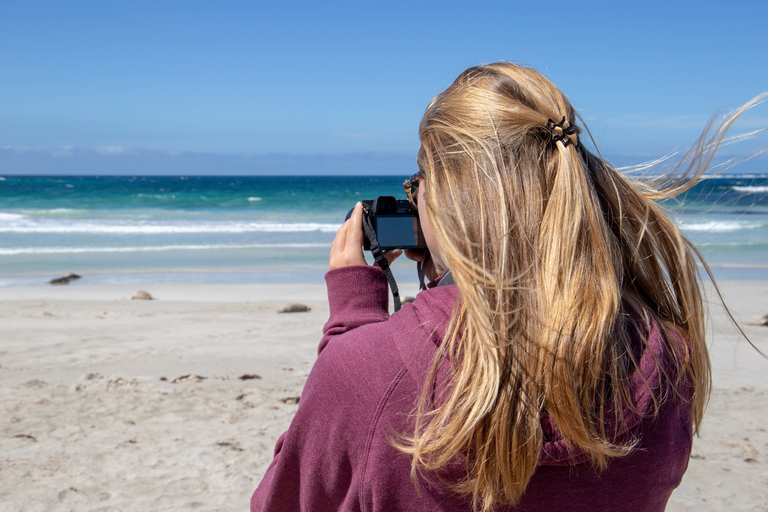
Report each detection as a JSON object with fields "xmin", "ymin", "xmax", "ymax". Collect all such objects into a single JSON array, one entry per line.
[{"xmin": 0, "ymin": 175, "xmax": 768, "ymax": 286}]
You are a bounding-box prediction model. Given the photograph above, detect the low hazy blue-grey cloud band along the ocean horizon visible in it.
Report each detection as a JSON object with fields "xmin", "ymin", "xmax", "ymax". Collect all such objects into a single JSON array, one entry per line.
[{"xmin": 0, "ymin": 145, "xmax": 768, "ymax": 176}]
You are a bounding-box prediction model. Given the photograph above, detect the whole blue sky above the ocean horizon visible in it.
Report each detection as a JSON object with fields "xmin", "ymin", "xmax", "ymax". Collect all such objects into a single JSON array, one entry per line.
[{"xmin": 0, "ymin": 0, "xmax": 768, "ymax": 174}]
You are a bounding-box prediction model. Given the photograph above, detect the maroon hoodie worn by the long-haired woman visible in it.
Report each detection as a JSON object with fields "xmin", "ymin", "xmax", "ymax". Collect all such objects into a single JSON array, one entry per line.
[{"xmin": 251, "ymin": 266, "xmax": 692, "ymax": 512}]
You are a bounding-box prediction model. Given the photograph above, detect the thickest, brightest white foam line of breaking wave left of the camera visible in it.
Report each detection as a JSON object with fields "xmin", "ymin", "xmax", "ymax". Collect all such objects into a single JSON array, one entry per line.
[{"xmin": 0, "ymin": 221, "xmax": 340, "ymax": 235}]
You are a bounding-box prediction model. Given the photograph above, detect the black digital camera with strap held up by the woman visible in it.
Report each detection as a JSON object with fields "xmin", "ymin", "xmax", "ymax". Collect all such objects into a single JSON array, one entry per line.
[{"xmin": 347, "ymin": 196, "xmax": 427, "ymax": 251}]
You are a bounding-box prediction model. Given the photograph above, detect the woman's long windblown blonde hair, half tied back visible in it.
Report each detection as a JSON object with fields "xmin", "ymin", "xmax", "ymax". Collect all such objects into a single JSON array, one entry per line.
[{"xmin": 397, "ymin": 63, "xmax": 764, "ymax": 511}]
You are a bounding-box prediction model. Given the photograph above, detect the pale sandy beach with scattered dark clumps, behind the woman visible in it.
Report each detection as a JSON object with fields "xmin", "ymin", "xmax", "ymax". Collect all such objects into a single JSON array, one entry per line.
[{"xmin": 0, "ymin": 281, "xmax": 768, "ymax": 512}]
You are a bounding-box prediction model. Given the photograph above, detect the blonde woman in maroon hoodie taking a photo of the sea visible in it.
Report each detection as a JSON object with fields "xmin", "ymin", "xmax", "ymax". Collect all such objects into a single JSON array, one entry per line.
[{"xmin": 251, "ymin": 63, "xmax": 756, "ymax": 511}]
